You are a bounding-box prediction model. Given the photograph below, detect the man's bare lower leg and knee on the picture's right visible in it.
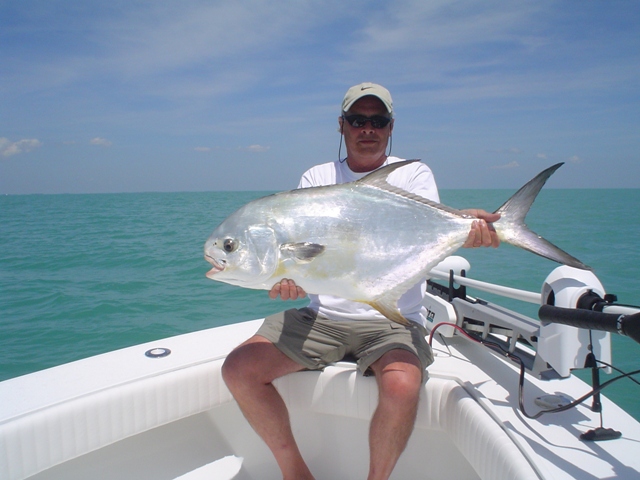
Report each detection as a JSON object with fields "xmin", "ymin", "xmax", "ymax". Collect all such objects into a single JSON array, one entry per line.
[{"xmin": 368, "ymin": 349, "xmax": 423, "ymax": 480}]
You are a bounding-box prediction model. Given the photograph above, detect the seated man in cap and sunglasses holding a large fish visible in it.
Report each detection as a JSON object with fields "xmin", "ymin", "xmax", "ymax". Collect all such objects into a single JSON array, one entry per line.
[{"xmin": 222, "ymin": 83, "xmax": 499, "ymax": 480}]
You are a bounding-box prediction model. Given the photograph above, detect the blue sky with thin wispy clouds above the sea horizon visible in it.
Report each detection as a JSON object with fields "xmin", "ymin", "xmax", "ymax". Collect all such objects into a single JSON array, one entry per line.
[{"xmin": 0, "ymin": 0, "xmax": 640, "ymax": 194}]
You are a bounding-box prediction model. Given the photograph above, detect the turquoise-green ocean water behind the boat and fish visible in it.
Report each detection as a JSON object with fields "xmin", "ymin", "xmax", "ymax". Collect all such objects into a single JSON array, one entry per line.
[{"xmin": 0, "ymin": 189, "xmax": 640, "ymax": 421}]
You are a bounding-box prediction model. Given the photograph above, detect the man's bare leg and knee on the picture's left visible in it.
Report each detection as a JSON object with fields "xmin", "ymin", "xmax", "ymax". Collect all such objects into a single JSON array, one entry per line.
[{"xmin": 222, "ymin": 335, "xmax": 313, "ymax": 480}]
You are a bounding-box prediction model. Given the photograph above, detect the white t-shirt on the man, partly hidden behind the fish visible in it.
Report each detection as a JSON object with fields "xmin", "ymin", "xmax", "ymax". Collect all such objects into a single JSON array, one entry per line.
[{"xmin": 298, "ymin": 157, "xmax": 440, "ymax": 326}]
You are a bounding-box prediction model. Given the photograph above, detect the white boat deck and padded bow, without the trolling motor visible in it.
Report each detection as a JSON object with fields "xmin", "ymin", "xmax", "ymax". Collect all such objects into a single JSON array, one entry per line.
[{"xmin": 0, "ymin": 321, "xmax": 640, "ymax": 480}]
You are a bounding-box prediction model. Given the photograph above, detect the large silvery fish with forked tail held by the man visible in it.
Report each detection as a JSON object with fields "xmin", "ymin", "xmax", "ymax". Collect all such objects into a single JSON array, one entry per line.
[{"xmin": 204, "ymin": 160, "xmax": 590, "ymax": 325}]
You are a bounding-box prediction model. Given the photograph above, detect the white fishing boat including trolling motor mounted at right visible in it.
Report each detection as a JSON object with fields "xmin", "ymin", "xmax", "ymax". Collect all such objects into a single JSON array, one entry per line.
[{"xmin": 0, "ymin": 257, "xmax": 640, "ymax": 480}]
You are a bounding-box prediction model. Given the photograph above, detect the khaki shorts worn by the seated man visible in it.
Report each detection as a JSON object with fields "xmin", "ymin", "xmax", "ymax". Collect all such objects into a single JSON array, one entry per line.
[{"xmin": 256, "ymin": 308, "xmax": 433, "ymax": 378}]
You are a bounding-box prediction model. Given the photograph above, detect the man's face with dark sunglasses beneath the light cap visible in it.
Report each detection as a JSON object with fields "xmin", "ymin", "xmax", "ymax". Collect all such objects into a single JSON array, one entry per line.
[{"xmin": 339, "ymin": 96, "xmax": 393, "ymax": 171}]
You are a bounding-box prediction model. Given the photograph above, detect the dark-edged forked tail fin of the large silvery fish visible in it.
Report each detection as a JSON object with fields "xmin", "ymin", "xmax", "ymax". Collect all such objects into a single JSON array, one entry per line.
[{"xmin": 493, "ymin": 163, "xmax": 591, "ymax": 270}]
